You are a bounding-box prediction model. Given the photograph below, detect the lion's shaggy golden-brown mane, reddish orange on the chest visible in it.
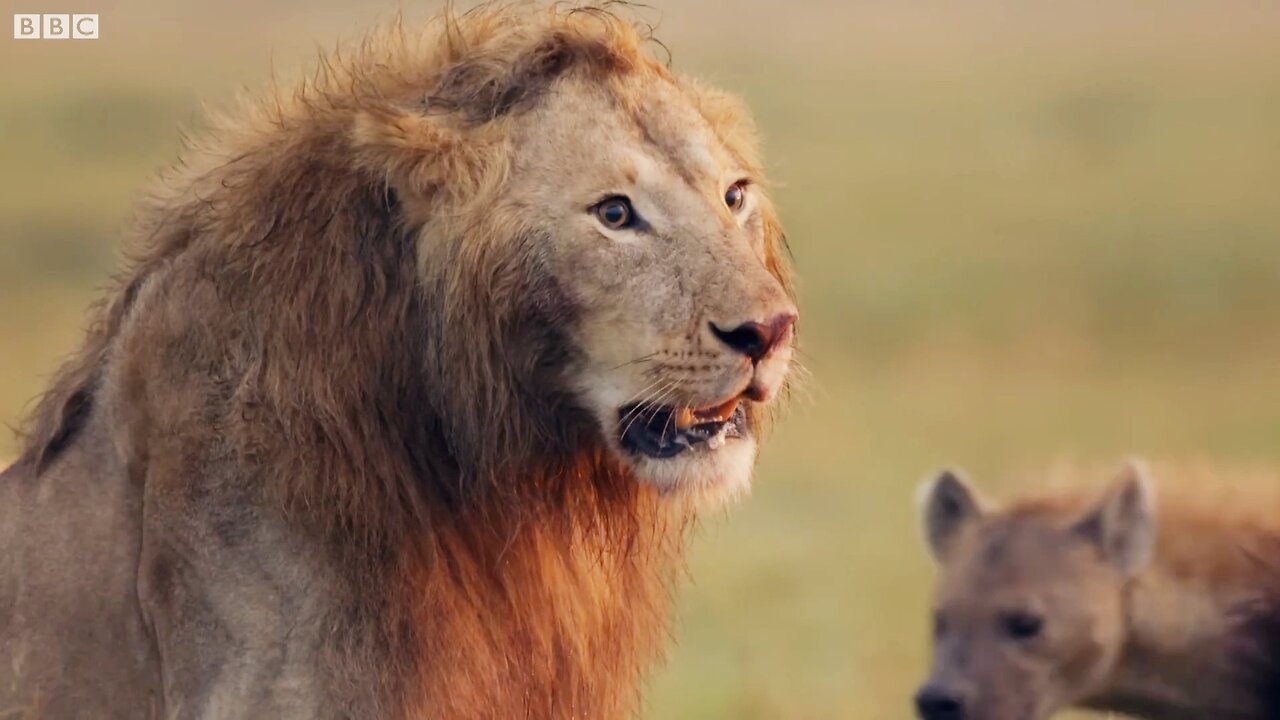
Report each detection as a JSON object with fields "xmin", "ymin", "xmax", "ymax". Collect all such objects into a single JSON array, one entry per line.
[{"xmin": 7, "ymin": 4, "xmax": 790, "ymax": 719}]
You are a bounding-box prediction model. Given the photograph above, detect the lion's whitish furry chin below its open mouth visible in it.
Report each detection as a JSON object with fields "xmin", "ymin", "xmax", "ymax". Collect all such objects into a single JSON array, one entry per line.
[{"xmin": 626, "ymin": 433, "xmax": 756, "ymax": 506}]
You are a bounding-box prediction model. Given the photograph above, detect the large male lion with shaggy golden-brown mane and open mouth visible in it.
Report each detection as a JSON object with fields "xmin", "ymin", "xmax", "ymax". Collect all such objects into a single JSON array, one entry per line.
[{"xmin": 0, "ymin": 4, "xmax": 797, "ymax": 719}]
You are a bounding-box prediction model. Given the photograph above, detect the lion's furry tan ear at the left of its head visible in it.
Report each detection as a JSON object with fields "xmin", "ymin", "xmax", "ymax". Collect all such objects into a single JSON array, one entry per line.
[{"xmin": 352, "ymin": 106, "xmax": 495, "ymax": 196}]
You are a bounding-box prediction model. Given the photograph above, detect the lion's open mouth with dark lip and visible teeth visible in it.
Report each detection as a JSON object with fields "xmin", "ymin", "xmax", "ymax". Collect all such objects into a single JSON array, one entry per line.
[{"xmin": 618, "ymin": 397, "xmax": 746, "ymax": 459}]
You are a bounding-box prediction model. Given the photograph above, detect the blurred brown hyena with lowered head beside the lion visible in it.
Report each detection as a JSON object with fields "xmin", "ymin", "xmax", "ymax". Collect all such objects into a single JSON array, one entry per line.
[{"xmin": 915, "ymin": 460, "xmax": 1280, "ymax": 720}]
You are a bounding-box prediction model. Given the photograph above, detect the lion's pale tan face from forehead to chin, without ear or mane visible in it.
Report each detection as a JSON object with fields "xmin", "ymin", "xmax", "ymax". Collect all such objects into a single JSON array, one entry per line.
[{"xmin": 504, "ymin": 77, "xmax": 796, "ymax": 493}]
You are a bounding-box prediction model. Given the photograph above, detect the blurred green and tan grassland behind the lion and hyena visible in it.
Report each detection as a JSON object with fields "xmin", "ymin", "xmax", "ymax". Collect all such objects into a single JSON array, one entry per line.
[{"xmin": 0, "ymin": 0, "xmax": 1280, "ymax": 720}]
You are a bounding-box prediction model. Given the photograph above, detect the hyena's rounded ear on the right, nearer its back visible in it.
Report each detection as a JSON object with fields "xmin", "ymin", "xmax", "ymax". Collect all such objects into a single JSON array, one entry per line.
[{"xmin": 1071, "ymin": 459, "xmax": 1156, "ymax": 578}]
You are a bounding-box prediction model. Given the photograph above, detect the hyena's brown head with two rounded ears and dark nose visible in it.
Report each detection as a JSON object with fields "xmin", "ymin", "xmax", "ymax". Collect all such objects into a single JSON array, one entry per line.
[{"xmin": 915, "ymin": 462, "xmax": 1156, "ymax": 720}]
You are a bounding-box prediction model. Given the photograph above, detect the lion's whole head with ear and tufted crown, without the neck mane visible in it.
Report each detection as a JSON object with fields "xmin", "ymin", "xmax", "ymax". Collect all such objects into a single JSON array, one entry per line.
[{"xmin": 353, "ymin": 10, "xmax": 796, "ymax": 495}]
